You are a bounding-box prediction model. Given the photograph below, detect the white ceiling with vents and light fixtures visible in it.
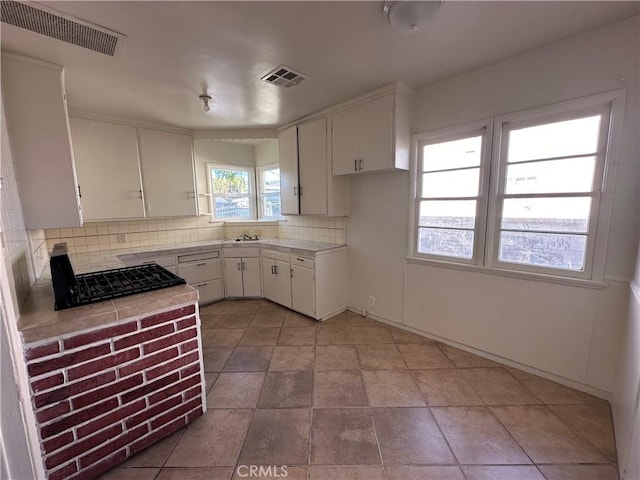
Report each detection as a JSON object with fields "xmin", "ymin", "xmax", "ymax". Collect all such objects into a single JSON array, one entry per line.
[{"xmin": 1, "ymin": 0, "xmax": 640, "ymax": 129}]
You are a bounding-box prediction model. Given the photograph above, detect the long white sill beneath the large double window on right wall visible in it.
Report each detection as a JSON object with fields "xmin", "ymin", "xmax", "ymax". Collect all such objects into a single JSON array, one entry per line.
[{"xmin": 405, "ymin": 257, "xmax": 609, "ymax": 290}]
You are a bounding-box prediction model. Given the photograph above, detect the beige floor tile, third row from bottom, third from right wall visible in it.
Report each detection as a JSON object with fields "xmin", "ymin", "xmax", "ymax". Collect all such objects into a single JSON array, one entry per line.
[{"xmin": 412, "ymin": 368, "xmax": 484, "ymax": 407}]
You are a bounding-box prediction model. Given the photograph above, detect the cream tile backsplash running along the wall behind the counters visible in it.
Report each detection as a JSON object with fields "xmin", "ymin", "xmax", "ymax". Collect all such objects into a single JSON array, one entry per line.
[{"xmin": 36, "ymin": 216, "xmax": 346, "ymax": 273}]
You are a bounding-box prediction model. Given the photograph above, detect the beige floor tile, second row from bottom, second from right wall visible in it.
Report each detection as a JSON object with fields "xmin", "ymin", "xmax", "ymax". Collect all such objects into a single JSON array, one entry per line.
[{"xmin": 491, "ymin": 406, "xmax": 607, "ymax": 464}]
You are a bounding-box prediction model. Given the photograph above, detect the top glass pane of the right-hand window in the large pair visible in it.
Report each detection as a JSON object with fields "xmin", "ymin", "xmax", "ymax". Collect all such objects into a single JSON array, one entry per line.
[{"xmin": 507, "ymin": 115, "xmax": 600, "ymax": 163}]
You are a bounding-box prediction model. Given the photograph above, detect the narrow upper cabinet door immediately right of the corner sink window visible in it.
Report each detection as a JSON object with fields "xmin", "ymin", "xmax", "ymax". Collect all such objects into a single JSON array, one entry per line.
[{"xmin": 278, "ymin": 126, "xmax": 300, "ymax": 215}]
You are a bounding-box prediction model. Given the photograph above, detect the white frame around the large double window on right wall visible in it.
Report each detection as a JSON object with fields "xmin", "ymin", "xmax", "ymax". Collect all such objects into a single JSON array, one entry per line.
[{"xmin": 408, "ymin": 90, "xmax": 625, "ymax": 287}]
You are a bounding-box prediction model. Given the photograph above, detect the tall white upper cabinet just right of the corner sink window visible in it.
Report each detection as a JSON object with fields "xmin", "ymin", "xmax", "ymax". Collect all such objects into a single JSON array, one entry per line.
[{"xmin": 279, "ymin": 117, "xmax": 349, "ymax": 216}]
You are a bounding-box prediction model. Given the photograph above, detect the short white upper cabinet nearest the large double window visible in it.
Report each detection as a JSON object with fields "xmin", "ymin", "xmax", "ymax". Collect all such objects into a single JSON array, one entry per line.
[{"xmin": 331, "ymin": 87, "xmax": 410, "ymax": 175}]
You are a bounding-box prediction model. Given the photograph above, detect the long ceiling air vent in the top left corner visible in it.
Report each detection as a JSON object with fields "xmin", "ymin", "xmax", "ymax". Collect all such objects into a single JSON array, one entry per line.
[{"xmin": 0, "ymin": 0, "xmax": 126, "ymax": 57}]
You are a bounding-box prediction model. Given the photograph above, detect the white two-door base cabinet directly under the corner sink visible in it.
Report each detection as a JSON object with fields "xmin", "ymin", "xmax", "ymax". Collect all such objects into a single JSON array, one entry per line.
[{"xmin": 224, "ymin": 248, "xmax": 262, "ymax": 297}]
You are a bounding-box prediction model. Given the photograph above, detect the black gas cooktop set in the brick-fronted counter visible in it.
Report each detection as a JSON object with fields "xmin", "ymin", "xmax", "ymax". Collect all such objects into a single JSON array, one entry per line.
[{"xmin": 50, "ymin": 243, "xmax": 187, "ymax": 310}]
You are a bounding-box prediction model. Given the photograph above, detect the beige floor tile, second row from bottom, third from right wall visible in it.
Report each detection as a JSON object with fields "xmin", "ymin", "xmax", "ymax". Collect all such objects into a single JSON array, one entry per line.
[{"xmin": 431, "ymin": 407, "xmax": 531, "ymax": 465}]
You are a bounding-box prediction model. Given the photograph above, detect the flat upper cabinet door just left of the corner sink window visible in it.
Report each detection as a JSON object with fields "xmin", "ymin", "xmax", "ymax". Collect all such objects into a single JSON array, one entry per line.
[{"xmin": 138, "ymin": 128, "xmax": 197, "ymax": 217}]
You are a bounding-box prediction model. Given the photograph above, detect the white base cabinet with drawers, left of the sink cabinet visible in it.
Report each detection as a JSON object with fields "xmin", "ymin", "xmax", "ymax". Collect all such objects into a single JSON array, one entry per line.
[{"xmin": 178, "ymin": 250, "xmax": 224, "ymax": 305}]
